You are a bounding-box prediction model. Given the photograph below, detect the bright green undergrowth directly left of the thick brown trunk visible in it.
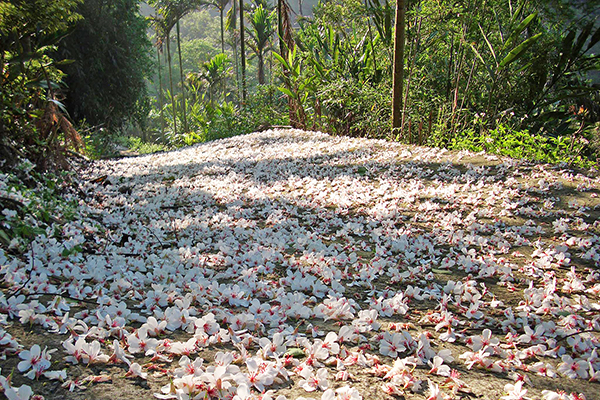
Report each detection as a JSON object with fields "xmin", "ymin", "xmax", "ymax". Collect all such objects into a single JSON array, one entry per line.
[{"xmin": 275, "ymin": 1, "xmax": 392, "ymax": 137}]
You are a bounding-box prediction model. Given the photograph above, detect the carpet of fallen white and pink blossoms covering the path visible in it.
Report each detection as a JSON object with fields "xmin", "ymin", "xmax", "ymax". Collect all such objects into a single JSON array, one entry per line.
[{"xmin": 0, "ymin": 130, "xmax": 600, "ymax": 400}]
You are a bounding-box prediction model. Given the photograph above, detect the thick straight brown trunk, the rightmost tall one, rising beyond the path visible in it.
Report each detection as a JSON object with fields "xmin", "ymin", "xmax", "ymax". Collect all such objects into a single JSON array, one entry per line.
[{"xmin": 392, "ymin": 0, "xmax": 406, "ymax": 129}]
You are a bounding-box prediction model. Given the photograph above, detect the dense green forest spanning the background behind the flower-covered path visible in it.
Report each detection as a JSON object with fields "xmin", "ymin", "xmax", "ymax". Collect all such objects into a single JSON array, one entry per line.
[{"xmin": 0, "ymin": 0, "xmax": 600, "ymax": 169}]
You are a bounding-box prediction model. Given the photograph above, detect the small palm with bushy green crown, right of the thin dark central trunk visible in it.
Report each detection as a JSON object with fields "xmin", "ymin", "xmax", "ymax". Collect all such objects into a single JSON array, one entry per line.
[{"xmin": 247, "ymin": 4, "xmax": 275, "ymax": 85}]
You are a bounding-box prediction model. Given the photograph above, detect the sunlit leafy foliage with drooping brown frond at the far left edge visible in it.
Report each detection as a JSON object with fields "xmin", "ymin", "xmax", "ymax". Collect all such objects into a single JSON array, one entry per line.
[{"xmin": 0, "ymin": 0, "xmax": 80, "ymax": 169}]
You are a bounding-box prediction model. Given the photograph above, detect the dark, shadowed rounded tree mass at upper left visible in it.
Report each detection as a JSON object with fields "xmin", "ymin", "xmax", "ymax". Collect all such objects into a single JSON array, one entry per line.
[{"xmin": 58, "ymin": 0, "xmax": 152, "ymax": 131}]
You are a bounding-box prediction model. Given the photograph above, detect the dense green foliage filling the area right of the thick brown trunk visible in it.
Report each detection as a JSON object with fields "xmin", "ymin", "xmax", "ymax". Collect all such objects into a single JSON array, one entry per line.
[{"xmin": 382, "ymin": 0, "xmax": 600, "ymax": 166}]
